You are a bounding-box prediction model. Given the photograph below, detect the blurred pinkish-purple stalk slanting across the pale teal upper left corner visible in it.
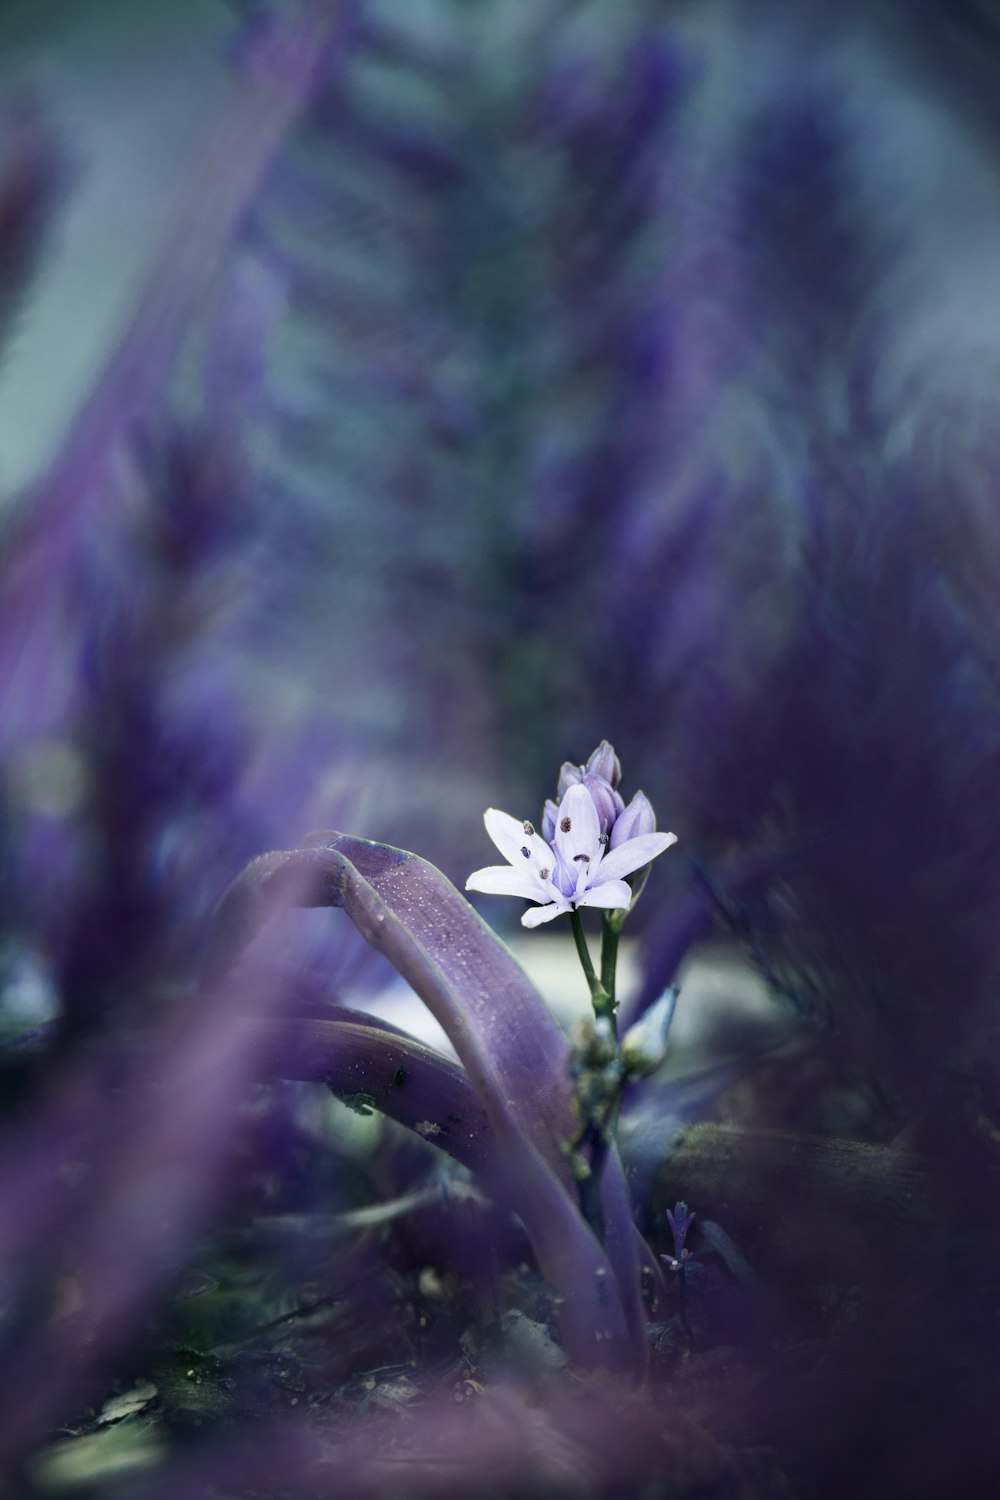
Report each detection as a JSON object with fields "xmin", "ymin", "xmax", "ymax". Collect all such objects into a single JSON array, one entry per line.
[{"xmin": 0, "ymin": 0, "xmax": 357, "ymax": 743}]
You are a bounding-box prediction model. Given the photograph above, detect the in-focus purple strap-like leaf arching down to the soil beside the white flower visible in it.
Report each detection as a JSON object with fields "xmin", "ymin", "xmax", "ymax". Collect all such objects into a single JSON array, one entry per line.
[{"xmin": 208, "ymin": 833, "xmax": 645, "ymax": 1368}]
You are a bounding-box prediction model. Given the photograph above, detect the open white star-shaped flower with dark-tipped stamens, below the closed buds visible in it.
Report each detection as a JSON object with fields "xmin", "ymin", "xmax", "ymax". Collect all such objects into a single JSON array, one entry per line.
[{"xmin": 465, "ymin": 783, "xmax": 676, "ymax": 927}]
